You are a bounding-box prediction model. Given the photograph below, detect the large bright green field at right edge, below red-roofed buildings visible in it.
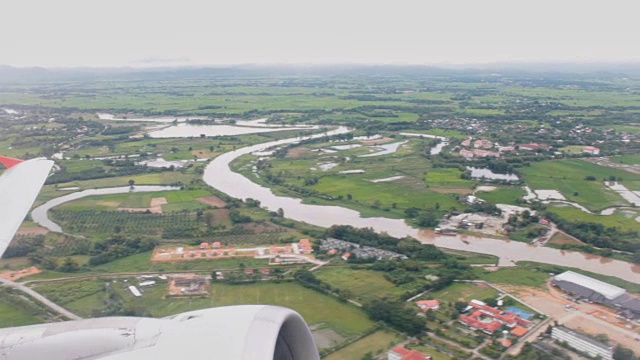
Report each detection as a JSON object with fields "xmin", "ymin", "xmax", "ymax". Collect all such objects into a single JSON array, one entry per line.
[{"xmin": 522, "ymin": 160, "xmax": 640, "ymax": 211}]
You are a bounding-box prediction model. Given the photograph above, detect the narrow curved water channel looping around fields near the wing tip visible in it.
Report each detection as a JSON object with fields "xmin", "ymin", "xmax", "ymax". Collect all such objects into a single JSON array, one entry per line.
[{"xmin": 31, "ymin": 185, "xmax": 180, "ymax": 233}]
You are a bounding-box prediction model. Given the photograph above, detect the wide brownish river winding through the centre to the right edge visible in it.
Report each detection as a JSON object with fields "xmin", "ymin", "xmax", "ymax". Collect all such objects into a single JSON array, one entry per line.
[{"xmin": 204, "ymin": 127, "xmax": 640, "ymax": 283}]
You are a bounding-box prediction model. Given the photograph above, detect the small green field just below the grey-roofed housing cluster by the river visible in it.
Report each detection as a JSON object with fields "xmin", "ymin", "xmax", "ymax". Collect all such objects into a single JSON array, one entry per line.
[{"xmin": 314, "ymin": 266, "xmax": 406, "ymax": 301}]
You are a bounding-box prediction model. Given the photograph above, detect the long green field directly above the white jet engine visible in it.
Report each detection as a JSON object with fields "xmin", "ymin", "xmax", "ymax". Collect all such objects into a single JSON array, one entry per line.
[{"xmin": 37, "ymin": 280, "xmax": 373, "ymax": 337}]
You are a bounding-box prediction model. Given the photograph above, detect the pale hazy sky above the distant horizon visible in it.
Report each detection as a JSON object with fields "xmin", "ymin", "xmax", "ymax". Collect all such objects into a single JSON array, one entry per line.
[{"xmin": 0, "ymin": 0, "xmax": 640, "ymax": 66}]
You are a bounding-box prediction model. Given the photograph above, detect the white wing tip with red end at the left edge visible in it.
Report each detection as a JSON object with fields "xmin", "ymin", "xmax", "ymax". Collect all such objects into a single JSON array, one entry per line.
[{"xmin": 0, "ymin": 156, "xmax": 53, "ymax": 256}]
